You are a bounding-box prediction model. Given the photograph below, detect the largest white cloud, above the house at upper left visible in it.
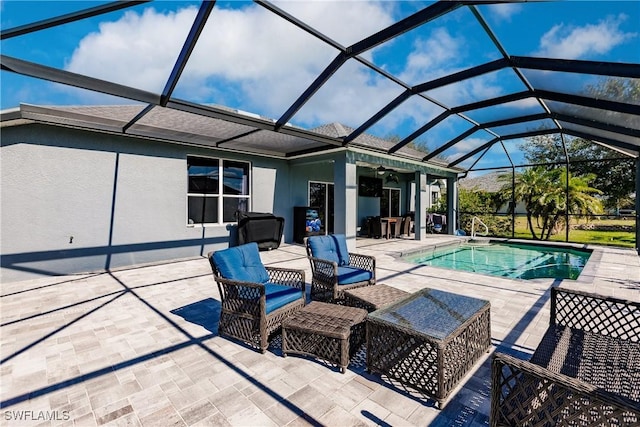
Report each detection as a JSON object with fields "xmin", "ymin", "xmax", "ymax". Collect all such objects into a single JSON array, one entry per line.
[{"xmin": 67, "ymin": 2, "xmax": 393, "ymax": 125}]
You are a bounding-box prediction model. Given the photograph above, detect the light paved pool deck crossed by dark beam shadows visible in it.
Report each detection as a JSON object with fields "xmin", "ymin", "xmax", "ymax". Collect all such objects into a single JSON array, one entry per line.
[{"xmin": 0, "ymin": 239, "xmax": 640, "ymax": 426}]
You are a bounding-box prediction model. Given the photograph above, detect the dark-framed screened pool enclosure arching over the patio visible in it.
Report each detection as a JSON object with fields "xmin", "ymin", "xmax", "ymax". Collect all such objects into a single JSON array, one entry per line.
[{"xmin": 1, "ymin": 1, "xmax": 640, "ymax": 252}]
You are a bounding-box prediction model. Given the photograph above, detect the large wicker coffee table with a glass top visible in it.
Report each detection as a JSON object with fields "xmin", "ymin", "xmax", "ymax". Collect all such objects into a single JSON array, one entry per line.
[{"xmin": 367, "ymin": 289, "xmax": 491, "ymax": 407}]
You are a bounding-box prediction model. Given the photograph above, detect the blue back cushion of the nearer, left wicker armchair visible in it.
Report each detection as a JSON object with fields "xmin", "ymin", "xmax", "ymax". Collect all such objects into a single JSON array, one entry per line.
[{"xmin": 212, "ymin": 242, "xmax": 269, "ymax": 283}]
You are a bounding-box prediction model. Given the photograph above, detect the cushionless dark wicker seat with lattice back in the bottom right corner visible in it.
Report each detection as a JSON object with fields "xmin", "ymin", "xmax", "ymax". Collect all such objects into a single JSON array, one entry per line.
[{"xmin": 491, "ymin": 288, "xmax": 640, "ymax": 426}]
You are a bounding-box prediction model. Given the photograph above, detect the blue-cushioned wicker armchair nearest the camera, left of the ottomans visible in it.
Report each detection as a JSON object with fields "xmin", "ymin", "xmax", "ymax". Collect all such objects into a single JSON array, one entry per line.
[{"xmin": 208, "ymin": 242, "xmax": 305, "ymax": 353}]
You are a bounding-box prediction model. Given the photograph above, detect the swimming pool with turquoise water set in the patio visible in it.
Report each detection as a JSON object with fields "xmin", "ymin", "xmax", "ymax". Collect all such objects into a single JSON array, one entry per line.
[{"xmin": 403, "ymin": 242, "xmax": 591, "ymax": 280}]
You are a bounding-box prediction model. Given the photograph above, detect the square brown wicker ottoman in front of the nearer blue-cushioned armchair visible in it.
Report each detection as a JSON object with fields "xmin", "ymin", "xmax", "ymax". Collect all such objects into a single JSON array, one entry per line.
[{"xmin": 282, "ymin": 301, "xmax": 367, "ymax": 373}]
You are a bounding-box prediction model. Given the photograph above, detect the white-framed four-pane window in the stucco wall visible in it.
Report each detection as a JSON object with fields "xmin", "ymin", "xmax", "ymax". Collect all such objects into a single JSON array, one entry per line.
[{"xmin": 187, "ymin": 156, "xmax": 251, "ymax": 225}]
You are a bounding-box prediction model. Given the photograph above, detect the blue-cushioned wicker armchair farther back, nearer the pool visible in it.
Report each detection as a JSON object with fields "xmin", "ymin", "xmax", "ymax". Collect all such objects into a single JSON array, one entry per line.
[{"xmin": 306, "ymin": 234, "xmax": 376, "ymax": 303}]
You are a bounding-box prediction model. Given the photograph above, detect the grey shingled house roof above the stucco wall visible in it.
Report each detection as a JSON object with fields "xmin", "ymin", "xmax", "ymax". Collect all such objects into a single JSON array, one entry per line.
[{"xmin": 2, "ymin": 104, "xmax": 455, "ymax": 174}]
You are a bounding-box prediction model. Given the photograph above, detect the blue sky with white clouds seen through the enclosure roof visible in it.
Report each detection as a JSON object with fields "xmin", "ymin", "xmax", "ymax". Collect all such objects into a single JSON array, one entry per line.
[{"xmin": 0, "ymin": 0, "xmax": 640, "ymax": 170}]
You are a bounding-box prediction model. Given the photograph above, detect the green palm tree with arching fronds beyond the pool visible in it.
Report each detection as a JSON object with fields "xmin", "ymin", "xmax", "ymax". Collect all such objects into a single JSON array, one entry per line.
[{"xmin": 502, "ymin": 166, "xmax": 602, "ymax": 240}]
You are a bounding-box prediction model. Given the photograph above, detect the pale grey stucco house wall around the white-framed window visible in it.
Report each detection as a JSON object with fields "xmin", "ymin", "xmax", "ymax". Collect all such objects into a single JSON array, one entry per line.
[{"xmin": 0, "ymin": 124, "xmax": 292, "ymax": 282}]
